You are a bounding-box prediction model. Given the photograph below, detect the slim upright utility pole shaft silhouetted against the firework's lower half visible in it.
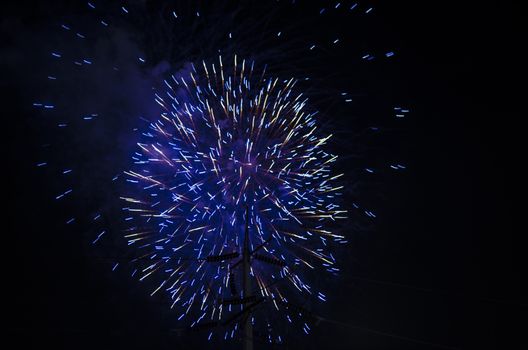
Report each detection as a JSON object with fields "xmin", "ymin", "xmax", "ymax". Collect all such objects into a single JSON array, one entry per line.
[{"xmin": 242, "ymin": 205, "xmax": 253, "ymax": 350}]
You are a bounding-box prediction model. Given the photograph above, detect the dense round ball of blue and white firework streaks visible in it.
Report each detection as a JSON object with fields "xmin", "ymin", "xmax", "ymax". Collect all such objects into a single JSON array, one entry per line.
[{"xmin": 122, "ymin": 56, "xmax": 346, "ymax": 342}]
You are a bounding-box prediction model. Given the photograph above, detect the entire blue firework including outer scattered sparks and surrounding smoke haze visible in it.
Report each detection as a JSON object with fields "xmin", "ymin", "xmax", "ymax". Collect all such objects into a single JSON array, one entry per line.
[{"xmin": 19, "ymin": 2, "xmax": 409, "ymax": 342}]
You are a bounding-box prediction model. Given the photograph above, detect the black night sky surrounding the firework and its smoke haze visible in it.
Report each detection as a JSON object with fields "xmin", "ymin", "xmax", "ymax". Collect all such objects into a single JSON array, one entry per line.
[{"xmin": 0, "ymin": 1, "xmax": 528, "ymax": 349}]
